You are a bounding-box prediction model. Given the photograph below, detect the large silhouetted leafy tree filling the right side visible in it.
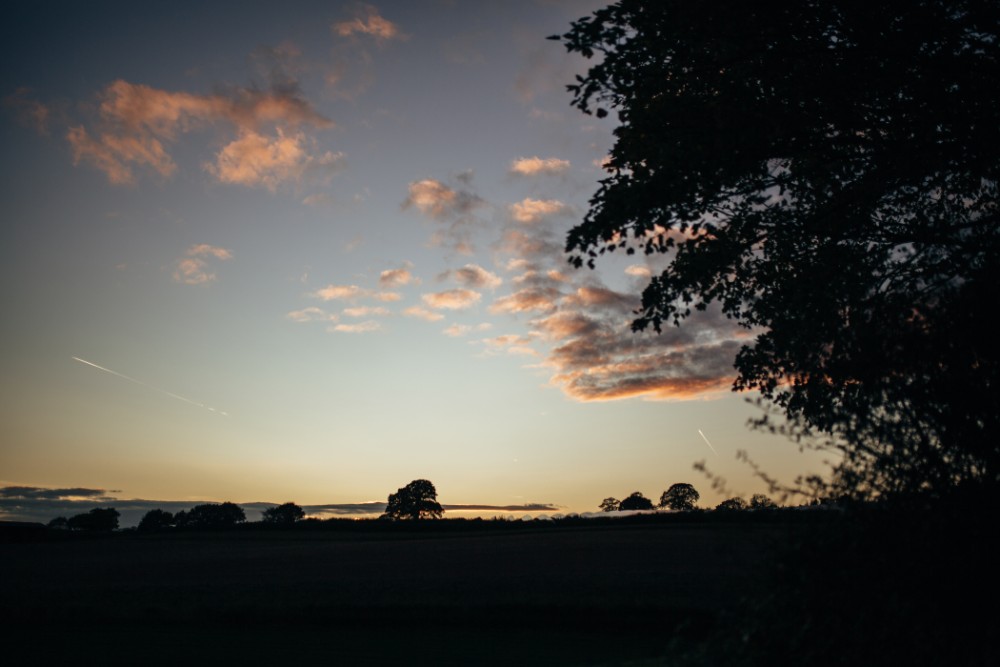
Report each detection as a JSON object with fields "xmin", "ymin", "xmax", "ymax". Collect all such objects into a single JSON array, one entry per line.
[{"xmin": 554, "ymin": 0, "xmax": 1000, "ymax": 493}]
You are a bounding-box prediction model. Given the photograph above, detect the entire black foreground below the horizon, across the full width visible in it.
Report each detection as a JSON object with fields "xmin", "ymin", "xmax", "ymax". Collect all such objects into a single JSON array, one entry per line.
[{"xmin": 0, "ymin": 510, "xmax": 1000, "ymax": 667}]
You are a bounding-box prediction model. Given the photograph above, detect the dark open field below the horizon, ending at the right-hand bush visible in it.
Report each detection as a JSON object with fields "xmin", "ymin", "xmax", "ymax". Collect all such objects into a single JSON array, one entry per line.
[{"xmin": 0, "ymin": 522, "xmax": 789, "ymax": 665}]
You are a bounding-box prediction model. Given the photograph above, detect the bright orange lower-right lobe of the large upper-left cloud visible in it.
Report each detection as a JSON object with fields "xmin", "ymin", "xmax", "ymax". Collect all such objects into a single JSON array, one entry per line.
[{"xmin": 204, "ymin": 129, "xmax": 344, "ymax": 192}]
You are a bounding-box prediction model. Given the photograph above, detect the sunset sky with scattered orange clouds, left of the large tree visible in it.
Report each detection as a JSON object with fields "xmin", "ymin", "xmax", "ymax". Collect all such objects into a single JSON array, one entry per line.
[{"xmin": 0, "ymin": 0, "xmax": 823, "ymax": 519}]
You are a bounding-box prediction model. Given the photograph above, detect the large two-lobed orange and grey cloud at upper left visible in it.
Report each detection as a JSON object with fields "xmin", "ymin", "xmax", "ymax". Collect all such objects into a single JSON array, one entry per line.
[{"xmin": 66, "ymin": 79, "xmax": 343, "ymax": 191}]
